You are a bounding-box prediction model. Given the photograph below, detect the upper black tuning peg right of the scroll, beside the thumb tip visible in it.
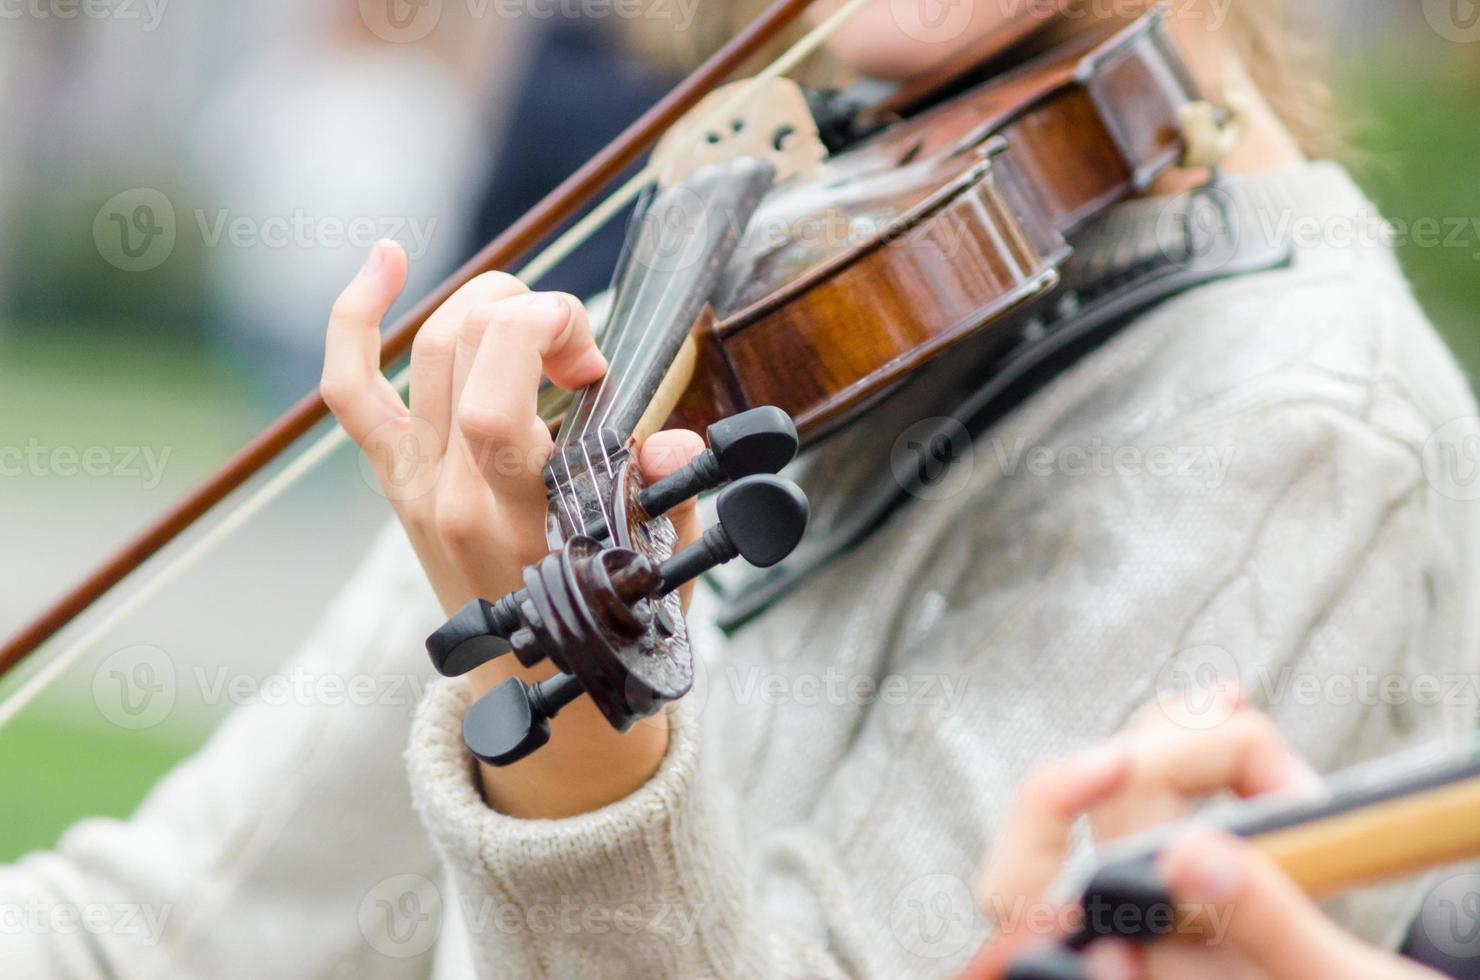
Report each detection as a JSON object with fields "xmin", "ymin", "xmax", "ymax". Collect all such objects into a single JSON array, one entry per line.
[{"xmin": 586, "ymin": 406, "xmax": 799, "ymax": 539}]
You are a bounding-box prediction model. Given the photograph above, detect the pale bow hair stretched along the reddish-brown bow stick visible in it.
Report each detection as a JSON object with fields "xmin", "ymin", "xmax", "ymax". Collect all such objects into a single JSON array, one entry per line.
[{"xmin": 0, "ymin": 0, "xmax": 872, "ymax": 728}]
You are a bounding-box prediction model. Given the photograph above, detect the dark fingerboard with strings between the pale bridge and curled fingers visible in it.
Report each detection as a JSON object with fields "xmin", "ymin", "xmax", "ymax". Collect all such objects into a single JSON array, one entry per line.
[{"xmin": 556, "ymin": 157, "xmax": 776, "ymax": 463}]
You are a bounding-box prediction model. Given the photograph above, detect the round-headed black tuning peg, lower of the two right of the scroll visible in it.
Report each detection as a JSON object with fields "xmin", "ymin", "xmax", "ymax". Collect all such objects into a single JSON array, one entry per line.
[{"xmin": 659, "ymin": 475, "xmax": 808, "ymax": 594}]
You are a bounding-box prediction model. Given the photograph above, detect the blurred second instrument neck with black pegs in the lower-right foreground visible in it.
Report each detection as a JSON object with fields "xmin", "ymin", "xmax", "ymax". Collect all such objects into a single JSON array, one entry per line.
[{"xmin": 1008, "ymin": 746, "xmax": 1480, "ymax": 980}]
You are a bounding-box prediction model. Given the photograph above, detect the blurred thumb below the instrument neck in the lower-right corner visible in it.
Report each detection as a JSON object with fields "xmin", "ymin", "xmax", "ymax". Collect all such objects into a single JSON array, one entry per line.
[{"xmin": 1160, "ymin": 829, "xmax": 1434, "ymax": 980}]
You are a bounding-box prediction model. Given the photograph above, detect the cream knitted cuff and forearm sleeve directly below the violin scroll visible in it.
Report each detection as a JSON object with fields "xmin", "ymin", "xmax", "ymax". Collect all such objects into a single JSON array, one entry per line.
[{"xmin": 408, "ymin": 681, "xmax": 786, "ymax": 980}]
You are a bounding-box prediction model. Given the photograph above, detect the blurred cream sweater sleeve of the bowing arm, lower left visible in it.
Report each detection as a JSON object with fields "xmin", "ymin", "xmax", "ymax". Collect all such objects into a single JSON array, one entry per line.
[{"xmin": 0, "ymin": 528, "xmax": 437, "ymax": 980}]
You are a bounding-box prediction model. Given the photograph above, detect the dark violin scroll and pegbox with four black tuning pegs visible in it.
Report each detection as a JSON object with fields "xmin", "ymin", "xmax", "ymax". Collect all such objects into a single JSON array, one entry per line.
[{"xmin": 426, "ymin": 407, "xmax": 808, "ymax": 765}]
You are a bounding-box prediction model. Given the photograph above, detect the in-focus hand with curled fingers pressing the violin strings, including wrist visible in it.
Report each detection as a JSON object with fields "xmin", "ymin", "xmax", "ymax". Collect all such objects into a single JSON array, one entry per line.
[{"xmin": 320, "ymin": 243, "xmax": 704, "ymax": 817}]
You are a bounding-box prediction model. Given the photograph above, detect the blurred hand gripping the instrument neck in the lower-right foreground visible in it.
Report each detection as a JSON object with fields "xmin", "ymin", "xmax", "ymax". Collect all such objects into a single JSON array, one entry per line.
[{"xmin": 963, "ymin": 700, "xmax": 1436, "ymax": 980}]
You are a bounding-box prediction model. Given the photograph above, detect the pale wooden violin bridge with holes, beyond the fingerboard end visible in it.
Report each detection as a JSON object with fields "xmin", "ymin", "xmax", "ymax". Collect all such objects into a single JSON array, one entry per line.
[{"xmin": 653, "ymin": 78, "xmax": 827, "ymax": 187}]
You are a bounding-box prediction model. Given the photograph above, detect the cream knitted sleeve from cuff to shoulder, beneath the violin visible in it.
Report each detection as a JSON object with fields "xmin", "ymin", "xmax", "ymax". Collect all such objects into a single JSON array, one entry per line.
[{"xmin": 410, "ymin": 174, "xmax": 1480, "ymax": 977}]
